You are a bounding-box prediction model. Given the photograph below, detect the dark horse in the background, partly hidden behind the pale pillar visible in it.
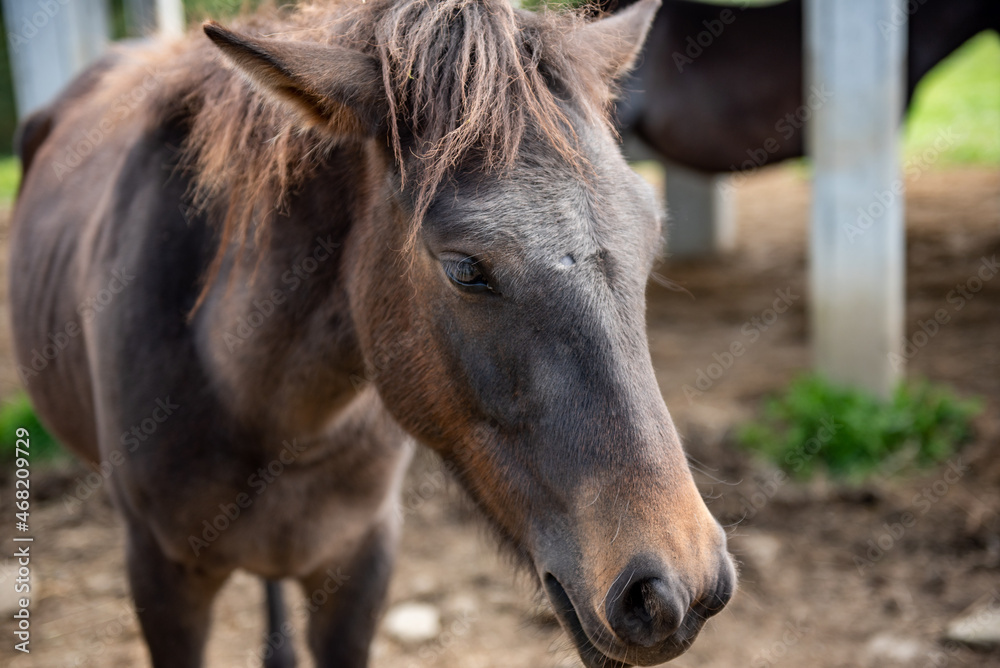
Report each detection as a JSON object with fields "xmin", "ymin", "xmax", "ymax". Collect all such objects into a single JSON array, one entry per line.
[{"xmin": 599, "ymin": 0, "xmax": 1000, "ymax": 172}]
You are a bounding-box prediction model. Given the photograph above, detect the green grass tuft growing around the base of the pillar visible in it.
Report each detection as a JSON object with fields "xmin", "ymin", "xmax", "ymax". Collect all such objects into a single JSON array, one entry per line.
[{"xmin": 737, "ymin": 376, "xmax": 981, "ymax": 481}]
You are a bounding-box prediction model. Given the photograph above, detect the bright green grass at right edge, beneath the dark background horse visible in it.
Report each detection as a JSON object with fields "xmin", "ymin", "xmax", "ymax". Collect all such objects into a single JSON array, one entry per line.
[{"xmin": 904, "ymin": 31, "xmax": 1000, "ymax": 166}]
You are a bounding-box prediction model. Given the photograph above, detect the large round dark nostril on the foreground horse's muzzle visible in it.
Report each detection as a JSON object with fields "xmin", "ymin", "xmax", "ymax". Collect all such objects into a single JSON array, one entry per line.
[{"xmin": 606, "ymin": 577, "xmax": 688, "ymax": 647}]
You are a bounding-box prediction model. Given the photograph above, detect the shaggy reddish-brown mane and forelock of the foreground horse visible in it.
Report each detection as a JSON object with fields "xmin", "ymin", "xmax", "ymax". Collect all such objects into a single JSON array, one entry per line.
[{"xmin": 111, "ymin": 0, "xmax": 612, "ymax": 308}]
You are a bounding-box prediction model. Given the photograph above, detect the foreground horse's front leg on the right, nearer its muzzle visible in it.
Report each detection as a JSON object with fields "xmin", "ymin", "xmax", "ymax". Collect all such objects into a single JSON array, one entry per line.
[{"xmin": 302, "ymin": 523, "xmax": 397, "ymax": 668}]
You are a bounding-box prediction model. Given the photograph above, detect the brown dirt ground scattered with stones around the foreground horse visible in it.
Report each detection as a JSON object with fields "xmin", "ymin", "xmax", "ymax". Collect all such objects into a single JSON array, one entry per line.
[{"xmin": 0, "ymin": 163, "xmax": 1000, "ymax": 668}]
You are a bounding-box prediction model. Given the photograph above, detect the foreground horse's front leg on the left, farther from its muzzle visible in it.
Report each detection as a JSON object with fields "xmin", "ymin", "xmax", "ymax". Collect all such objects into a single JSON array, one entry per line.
[{"xmin": 126, "ymin": 523, "xmax": 229, "ymax": 668}]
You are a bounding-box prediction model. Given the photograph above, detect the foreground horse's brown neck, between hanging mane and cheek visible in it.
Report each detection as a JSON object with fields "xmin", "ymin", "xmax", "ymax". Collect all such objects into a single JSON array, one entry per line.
[{"xmin": 198, "ymin": 141, "xmax": 377, "ymax": 439}]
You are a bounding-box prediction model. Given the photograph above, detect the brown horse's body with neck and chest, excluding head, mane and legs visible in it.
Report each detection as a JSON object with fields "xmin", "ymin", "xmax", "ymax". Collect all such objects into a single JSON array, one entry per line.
[{"xmin": 11, "ymin": 36, "xmax": 410, "ymax": 577}]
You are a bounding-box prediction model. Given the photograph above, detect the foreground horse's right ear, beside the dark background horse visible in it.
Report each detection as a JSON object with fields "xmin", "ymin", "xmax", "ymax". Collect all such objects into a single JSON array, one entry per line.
[{"xmin": 568, "ymin": 0, "xmax": 660, "ymax": 81}]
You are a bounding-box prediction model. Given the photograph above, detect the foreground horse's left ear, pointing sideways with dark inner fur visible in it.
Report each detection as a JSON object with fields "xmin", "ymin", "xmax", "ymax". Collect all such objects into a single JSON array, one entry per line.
[{"xmin": 203, "ymin": 21, "xmax": 388, "ymax": 136}]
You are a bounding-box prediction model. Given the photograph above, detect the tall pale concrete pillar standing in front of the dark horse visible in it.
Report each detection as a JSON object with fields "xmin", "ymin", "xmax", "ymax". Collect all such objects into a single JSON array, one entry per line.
[{"xmin": 805, "ymin": 0, "xmax": 906, "ymax": 396}]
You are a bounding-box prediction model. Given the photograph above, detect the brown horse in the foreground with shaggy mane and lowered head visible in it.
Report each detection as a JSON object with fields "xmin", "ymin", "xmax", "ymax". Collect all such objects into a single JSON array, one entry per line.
[{"xmin": 11, "ymin": 0, "xmax": 735, "ymax": 668}]
